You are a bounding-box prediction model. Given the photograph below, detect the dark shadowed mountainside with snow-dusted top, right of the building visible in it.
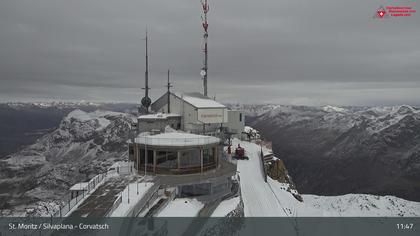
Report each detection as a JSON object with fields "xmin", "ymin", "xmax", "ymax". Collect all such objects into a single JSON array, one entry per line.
[{"xmin": 245, "ymin": 106, "xmax": 420, "ymax": 201}]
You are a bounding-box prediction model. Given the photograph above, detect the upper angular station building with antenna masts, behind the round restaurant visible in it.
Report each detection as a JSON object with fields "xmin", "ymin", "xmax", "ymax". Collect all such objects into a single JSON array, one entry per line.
[{"xmin": 131, "ymin": 0, "xmax": 245, "ymax": 137}]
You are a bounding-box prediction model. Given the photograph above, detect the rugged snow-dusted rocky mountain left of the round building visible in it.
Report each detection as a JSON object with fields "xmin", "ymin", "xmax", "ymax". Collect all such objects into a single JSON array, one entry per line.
[{"xmin": 0, "ymin": 110, "xmax": 134, "ymax": 214}]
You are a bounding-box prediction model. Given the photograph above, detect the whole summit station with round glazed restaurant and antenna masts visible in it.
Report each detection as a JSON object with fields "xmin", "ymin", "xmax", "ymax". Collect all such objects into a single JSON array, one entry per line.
[{"xmin": 129, "ymin": 0, "xmax": 245, "ymax": 183}]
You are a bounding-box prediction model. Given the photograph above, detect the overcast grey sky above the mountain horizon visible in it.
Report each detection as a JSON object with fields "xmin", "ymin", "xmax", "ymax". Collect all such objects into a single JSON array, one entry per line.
[{"xmin": 0, "ymin": 0, "xmax": 420, "ymax": 105}]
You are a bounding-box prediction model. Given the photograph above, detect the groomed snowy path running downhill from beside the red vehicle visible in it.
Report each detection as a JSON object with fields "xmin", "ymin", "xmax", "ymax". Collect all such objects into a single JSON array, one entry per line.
[{"xmin": 233, "ymin": 140, "xmax": 287, "ymax": 216}]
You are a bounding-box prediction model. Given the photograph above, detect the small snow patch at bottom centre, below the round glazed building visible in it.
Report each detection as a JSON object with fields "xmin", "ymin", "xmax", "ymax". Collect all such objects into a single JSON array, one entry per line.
[{"xmin": 158, "ymin": 198, "xmax": 204, "ymax": 217}]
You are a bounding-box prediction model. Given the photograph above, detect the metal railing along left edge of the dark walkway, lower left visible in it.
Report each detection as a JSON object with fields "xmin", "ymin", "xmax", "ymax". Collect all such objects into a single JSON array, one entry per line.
[{"xmin": 51, "ymin": 172, "xmax": 107, "ymax": 217}]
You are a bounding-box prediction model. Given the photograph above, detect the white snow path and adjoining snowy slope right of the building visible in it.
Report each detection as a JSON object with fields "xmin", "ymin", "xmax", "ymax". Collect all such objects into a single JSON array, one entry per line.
[{"xmin": 233, "ymin": 139, "xmax": 420, "ymax": 217}]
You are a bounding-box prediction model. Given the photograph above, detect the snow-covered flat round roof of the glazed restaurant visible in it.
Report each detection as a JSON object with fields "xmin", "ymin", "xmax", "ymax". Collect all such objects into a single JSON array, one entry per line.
[{"xmin": 135, "ymin": 132, "xmax": 220, "ymax": 147}]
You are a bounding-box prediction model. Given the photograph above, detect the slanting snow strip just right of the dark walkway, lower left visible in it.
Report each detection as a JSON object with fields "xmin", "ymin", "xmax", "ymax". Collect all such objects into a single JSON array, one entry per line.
[{"xmin": 111, "ymin": 182, "xmax": 153, "ymax": 217}]
